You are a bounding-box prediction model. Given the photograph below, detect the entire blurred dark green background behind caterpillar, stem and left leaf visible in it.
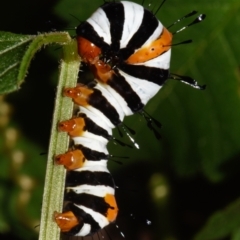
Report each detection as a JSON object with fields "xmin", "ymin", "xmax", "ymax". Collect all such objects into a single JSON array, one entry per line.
[{"xmin": 0, "ymin": 0, "xmax": 240, "ymax": 240}]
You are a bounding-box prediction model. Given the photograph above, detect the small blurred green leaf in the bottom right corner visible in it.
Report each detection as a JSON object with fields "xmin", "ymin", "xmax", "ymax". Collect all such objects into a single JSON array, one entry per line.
[{"xmin": 194, "ymin": 199, "xmax": 240, "ymax": 240}]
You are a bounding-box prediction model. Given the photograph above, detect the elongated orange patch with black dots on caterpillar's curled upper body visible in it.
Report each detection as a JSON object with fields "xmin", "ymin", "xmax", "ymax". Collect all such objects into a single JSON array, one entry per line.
[{"xmin": 126, "ymin": 28, "xmax": 172, "ymax": 64}]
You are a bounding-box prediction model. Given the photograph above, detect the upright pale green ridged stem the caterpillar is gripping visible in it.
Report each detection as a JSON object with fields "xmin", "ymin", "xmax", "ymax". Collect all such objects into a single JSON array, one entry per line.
[{"xmin": 39, "ymin": 37, "xmax": 80, "ymax": 240}]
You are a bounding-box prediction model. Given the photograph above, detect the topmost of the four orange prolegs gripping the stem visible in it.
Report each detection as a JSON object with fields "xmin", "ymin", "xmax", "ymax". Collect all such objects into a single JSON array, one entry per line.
[{"xmin": 63, "ymin": 85, "xmax": 93, "ymax": 107}]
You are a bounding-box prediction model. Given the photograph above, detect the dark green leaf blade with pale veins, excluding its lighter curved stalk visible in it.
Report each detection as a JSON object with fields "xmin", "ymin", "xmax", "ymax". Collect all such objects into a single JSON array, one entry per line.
[{"xmin": 0, "ymin": 32, "xmax": 35, "ymax": 94}]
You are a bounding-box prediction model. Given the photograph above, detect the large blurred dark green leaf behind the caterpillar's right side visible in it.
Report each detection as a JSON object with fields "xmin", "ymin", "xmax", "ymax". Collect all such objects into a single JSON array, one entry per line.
[{"xmin": 158, "ymin": 0, "xmax": 240, "ymax": 182}]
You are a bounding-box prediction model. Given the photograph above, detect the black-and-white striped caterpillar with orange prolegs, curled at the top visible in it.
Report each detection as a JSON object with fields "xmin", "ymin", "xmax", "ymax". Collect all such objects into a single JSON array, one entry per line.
[{"xmin": 54, "ymin": 1, "xmax": 204, "ymax": 236}]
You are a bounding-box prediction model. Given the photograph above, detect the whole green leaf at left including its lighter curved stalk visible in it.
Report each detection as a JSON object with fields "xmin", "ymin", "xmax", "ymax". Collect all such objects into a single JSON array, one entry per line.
[{"xmin": 0, "ymin": 32, "xmax": 71, "ymax": 94}]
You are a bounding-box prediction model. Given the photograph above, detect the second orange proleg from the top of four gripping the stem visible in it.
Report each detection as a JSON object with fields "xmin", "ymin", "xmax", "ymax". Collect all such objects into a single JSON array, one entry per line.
[{"xmin": 58, "ymin": 117, "xmax": 85, "ymax": 137}]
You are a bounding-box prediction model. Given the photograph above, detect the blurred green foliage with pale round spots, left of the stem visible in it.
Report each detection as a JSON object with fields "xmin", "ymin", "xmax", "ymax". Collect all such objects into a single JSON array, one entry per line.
[{"xmin": 0, "ymin": 98, "xmax": 45, "ymax": 239}]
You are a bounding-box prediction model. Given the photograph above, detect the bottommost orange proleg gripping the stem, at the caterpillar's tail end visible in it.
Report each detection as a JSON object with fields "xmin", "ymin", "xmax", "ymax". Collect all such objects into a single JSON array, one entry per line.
[{"xmin": 53, "ymin": 211, "xmax": 79, "ymax": 232}]
